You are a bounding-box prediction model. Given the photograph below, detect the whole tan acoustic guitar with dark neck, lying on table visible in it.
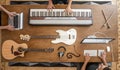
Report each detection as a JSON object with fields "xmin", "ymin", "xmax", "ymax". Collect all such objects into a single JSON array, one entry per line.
[{"xmin": 2, "ymin": 40, "xmax": 54, "ymax": 60}]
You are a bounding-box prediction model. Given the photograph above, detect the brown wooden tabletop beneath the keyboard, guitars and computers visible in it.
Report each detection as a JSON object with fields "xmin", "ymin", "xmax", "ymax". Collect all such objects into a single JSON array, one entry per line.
[{"xmin": 2, "ymin": 5, "xmax": 118, "ymax": 62}]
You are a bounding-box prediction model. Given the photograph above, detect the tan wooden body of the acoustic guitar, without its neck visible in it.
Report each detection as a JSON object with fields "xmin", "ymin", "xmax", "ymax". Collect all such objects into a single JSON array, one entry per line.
[{"xmin": 2, "ymin": 40, "xmax": 28, "ymax": 60}]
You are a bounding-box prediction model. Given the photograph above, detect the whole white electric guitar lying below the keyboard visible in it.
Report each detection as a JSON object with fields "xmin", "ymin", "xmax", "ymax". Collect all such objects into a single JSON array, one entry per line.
[{"xmin": 20, "ymin": 29, "xmax": 77, "ymax": 45}]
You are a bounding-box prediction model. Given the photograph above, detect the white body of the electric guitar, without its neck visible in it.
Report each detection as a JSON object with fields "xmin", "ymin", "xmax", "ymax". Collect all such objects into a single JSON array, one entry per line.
[{"xmin": 51, "ymin": 29, "xmax": 77, "ymax": 45}]
